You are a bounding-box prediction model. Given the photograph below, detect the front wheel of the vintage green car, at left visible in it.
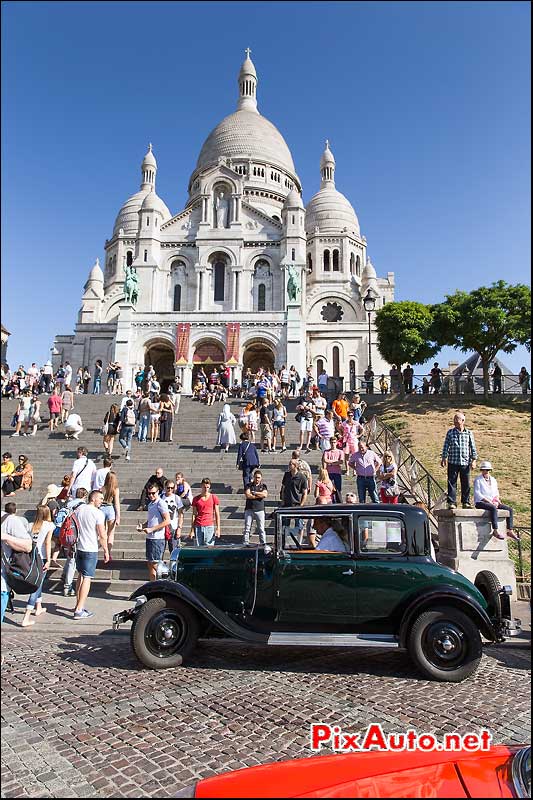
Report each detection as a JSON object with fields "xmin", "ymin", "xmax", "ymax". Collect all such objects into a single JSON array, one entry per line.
[{"xmin": 131, "ymin": 595, "xmax": 198, "ymax": 669}]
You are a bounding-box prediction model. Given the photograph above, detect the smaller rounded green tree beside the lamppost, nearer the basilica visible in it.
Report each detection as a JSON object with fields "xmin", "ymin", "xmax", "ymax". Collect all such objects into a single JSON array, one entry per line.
[{"xmin": 376, "ymin": 300, "xmax": 440, "ymax": 393}]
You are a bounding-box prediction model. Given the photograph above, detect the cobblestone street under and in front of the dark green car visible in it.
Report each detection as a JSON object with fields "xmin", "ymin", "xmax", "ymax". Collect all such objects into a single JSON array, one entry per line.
[{"xmin": 1, "ymin": 631, "xmax": 530, "ymax": 797}]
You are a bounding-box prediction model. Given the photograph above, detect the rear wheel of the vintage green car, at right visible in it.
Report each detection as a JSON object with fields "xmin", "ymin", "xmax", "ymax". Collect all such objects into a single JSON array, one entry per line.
[{"xmin": 407, "ymin": 607, "xmax": 482, "ymax": 682}]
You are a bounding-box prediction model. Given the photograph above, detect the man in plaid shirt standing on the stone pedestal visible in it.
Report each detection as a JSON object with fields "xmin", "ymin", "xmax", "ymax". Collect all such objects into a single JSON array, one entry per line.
[{"xmin": 440, "ymin": 411, "xmax": 477, "ymax": 508}]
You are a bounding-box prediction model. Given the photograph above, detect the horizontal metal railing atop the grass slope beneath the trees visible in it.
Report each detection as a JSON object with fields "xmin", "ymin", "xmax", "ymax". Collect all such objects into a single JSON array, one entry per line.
[{"xmin": 344, "ymin": 373, "xmax": 531, "ymax": 396}]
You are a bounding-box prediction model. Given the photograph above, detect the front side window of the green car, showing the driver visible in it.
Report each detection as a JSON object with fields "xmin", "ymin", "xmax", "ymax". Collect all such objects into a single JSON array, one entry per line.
[{"xmin": 279, "ymin": 512, "xmax": 352, "ymax": 555}]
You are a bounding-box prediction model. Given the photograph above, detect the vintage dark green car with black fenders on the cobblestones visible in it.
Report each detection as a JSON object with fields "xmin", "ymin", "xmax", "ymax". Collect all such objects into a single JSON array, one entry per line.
[{"xmin": 113, "ymin": 505, "xmax": 520, "ymax": 681}]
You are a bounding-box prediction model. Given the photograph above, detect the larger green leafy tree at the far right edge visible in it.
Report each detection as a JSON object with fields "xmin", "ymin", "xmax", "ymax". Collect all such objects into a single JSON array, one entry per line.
[{"xmin": 432, "ymin": 281, "xmax": 531, "ymax": 398}]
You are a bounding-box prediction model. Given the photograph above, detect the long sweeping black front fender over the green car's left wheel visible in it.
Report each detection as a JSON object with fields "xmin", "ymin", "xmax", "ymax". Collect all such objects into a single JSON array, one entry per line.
[{"xmin": 130, "ymin": 580, "xmax": 270, "ymax": 644}]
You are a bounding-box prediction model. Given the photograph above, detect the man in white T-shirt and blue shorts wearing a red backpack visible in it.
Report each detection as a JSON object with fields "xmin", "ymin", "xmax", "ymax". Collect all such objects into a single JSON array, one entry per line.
[{"xmin": 74, "ymin": 489, "xmax": 109, "ymax": 619}]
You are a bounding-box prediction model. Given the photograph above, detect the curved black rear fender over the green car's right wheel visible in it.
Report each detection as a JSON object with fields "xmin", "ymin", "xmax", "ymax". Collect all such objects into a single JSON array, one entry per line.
[{"xmin": 398, "ymin": 586, "xmax": 494, "ymax": 647}]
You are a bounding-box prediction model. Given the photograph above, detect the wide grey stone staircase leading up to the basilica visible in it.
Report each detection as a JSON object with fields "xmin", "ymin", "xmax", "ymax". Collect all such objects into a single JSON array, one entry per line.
[{"xmin": 1, "ymin": 395, "xmax": 328, "ymax": 591}]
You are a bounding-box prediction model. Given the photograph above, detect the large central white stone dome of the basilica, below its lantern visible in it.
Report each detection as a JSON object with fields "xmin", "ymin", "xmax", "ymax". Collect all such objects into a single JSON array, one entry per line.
[{"xmin": 196, "ymin": 110, "xmax": 296, "ymax": 175}]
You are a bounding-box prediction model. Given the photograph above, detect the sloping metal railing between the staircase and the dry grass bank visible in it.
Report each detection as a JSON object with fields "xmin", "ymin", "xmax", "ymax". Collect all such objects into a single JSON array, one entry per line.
[{"xmin": 367, "ymin": 416, "xmax": 446, "ymax": 525}]
